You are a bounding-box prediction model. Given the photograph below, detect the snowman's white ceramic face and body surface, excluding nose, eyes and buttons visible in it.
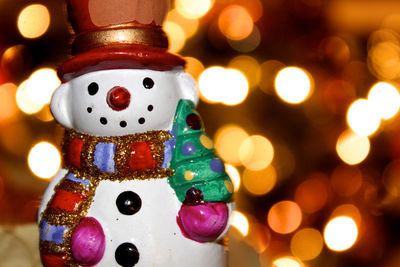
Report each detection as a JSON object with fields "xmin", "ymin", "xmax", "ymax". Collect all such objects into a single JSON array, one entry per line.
[{"xmin": 39, "ymin": 70, "xmax": 232, "ymax": 267}]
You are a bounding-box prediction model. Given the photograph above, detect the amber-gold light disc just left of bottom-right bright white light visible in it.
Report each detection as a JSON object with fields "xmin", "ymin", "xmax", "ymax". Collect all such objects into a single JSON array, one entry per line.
[{"xmin": 290, "ymin": 228, "xmax": 324, "ymax": 261}]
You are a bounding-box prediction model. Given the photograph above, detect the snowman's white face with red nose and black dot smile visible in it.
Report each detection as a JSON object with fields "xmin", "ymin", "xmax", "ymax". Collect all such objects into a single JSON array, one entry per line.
[{"xmin": 51, "ymin": 69, "xmax": 197, "ymax": 136}]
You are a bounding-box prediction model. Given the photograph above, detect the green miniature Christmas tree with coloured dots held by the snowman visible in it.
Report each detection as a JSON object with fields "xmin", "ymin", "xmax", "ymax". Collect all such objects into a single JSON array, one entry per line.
[{"xmin": 168, "ymin": 100, "xmax": 233, "ymax": 202}]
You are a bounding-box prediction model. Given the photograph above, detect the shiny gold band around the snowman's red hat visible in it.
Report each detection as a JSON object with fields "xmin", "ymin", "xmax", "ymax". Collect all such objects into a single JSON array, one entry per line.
[{"xmin": 71, "ymin": 23, "xmax": 168, "ymax": 55}]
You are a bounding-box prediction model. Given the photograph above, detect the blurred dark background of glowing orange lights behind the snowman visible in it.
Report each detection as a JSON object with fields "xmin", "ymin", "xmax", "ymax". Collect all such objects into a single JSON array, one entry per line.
[{"xmin": 0, "ymin": 0, "xmax": 400, "ymax": 267}]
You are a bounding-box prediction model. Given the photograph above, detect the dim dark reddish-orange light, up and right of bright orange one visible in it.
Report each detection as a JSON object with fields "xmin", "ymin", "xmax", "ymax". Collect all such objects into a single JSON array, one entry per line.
[{"xmin": 295, "ymin": 173, "xmax": 328, "ymax": 216}]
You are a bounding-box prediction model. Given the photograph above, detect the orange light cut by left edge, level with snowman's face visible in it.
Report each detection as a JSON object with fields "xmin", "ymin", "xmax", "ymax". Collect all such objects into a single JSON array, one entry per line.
[{"xmin": 0, "ymin": 83, "xmax": 17, "ymax": 121}]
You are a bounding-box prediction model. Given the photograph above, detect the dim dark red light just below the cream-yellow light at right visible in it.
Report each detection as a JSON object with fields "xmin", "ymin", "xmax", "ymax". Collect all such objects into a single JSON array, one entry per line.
[{"xmin": 331, "ymin": 165, "xmax": 363, "ymax": 197}]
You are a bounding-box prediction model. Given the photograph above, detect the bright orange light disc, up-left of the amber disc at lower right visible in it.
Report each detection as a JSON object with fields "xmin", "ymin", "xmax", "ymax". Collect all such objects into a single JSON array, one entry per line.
[{"xmin": 268, "ymin": 200, "xmax": 302, "ymax": 234}]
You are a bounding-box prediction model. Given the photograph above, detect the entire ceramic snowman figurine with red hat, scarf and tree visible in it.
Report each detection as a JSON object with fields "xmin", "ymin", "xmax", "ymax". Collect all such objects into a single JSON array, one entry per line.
[{"xmin": 39, "ymin": 0, "xmax": 233, "ymax": 267}]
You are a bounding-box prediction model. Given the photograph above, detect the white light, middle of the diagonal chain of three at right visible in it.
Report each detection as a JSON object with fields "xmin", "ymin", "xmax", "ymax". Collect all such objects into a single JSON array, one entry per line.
[{"xmin": 347, "ymin": 99, "xmax": 381, "ymax": 136}]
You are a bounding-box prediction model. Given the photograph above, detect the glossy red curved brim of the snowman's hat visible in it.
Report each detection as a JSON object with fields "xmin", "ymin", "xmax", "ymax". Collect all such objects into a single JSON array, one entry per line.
[{"xmin": 58, "ymin": 45, "xmax": 185, "ymax": 82}]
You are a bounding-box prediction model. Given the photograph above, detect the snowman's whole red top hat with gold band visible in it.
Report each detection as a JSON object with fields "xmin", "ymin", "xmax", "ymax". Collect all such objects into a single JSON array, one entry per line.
[{"xmin": 58, "ymin": 0, "xmax": 185, "ymax": 81}]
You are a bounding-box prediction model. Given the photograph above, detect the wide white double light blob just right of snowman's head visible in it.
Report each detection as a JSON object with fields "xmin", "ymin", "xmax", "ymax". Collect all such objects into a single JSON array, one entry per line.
[{"xmin": 199, "ymin": 66, "xmax": 249, "ymax": 106}]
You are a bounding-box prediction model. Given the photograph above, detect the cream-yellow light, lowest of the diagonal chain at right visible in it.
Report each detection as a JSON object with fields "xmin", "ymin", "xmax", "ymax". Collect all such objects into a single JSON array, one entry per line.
[{"xmin": 336, "ymin": 130, "xmax": 370, "ymax": 165}]
